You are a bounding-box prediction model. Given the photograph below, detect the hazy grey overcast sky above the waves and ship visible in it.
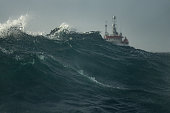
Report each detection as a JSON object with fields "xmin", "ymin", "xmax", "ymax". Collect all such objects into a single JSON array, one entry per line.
[{"xmin": 0, "ymin": 0, "xmax": 170, "ymax": 52}]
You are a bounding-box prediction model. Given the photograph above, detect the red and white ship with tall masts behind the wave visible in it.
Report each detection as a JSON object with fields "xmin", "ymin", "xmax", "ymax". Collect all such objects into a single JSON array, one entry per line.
[{"xmin": 104, "ymin": 16, "xmax": 129, "ymax": 46}]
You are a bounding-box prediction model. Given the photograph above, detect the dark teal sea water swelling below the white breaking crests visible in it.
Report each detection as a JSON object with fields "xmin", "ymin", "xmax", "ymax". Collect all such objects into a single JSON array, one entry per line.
[{"xmin": 0, "ymin": 28, "xmax": 170, "ymax": 113}]
